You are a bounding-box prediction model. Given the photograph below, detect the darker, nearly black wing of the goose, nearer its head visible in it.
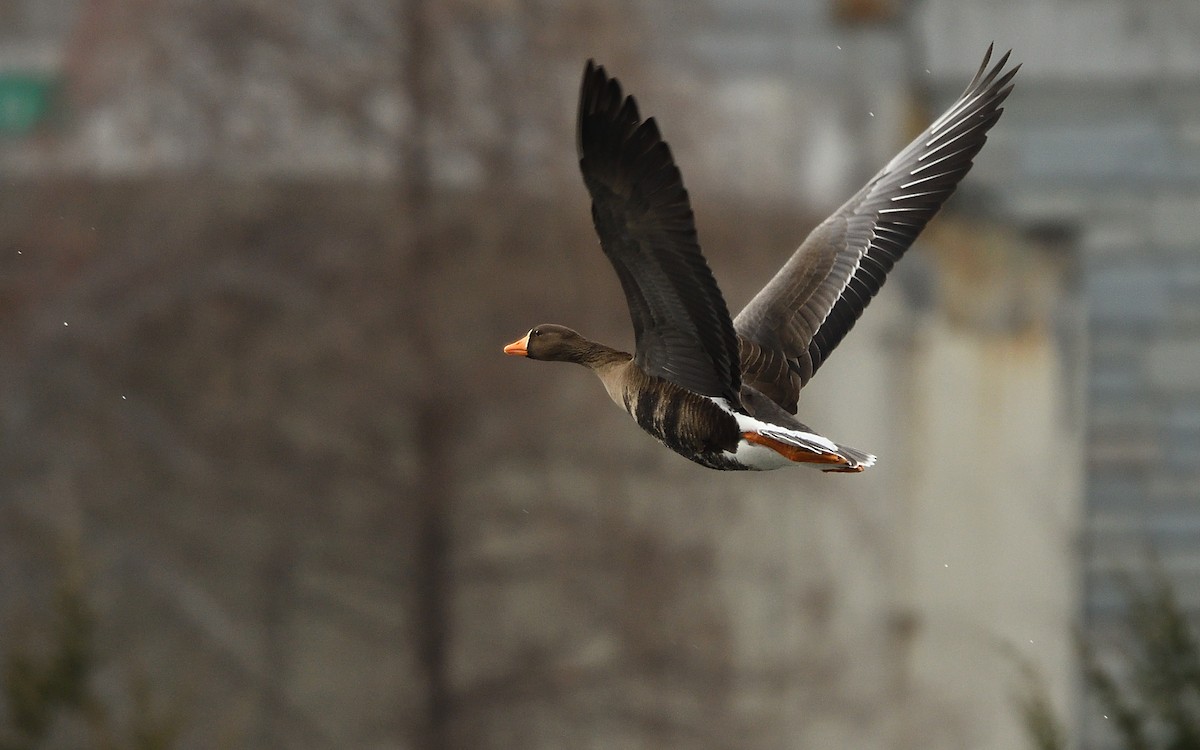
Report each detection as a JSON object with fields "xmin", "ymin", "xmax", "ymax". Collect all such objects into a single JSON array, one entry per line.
[{"xmin": 576, "ymin": 60, "xmax": 740, "ymax": 403}]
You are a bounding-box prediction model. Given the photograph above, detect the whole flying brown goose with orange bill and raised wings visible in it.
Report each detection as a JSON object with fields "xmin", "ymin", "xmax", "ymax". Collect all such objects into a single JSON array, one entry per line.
[{"xmin": 504, "ymin": 47, "xmax": 1020, "ymax": 472}]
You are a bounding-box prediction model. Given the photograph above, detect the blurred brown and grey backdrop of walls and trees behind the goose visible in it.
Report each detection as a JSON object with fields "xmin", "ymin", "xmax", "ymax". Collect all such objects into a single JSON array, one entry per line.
[{"xmin": 0, "ymin": 0, "xmax": 1200, "ymax": 750}]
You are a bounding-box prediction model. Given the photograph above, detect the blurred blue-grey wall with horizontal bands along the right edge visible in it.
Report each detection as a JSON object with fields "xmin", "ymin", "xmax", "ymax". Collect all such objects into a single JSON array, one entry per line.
[{"xmin": 916, "ymin": 0, "xmax": 1200, "ymax": 746}]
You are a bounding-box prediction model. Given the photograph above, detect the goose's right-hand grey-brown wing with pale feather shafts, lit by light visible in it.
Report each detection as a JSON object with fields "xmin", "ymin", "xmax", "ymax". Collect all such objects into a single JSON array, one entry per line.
[{"xmin": 734, "ymin": 46, "xmax": 1020, "ymax": 414}]
